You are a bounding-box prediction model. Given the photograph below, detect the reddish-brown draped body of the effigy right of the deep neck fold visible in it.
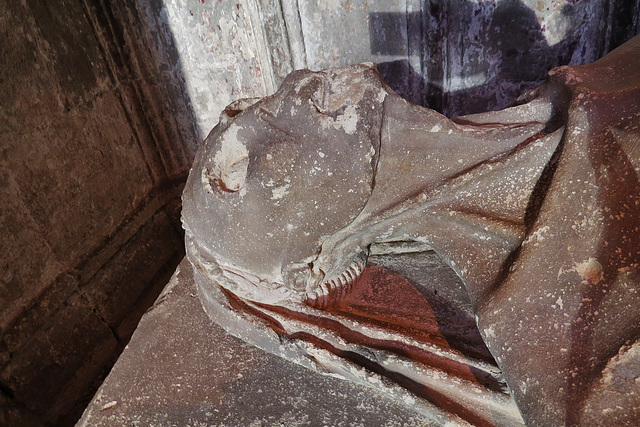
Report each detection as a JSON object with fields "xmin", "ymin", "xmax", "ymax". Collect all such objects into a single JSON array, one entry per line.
[{"xmin": 477, "ymin": 37, "xmax": 640, "ymax": 425}]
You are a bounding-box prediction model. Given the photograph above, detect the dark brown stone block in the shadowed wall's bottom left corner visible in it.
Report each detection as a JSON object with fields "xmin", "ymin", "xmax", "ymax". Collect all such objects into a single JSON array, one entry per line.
[{"xmin": 0, "ymin": 295, "xmax": 117, "ymax": 423}]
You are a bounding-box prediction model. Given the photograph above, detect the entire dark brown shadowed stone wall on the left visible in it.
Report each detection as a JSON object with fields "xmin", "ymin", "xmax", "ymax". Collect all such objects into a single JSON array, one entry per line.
[{"xmin": 0, "ymin": 0, "xmax": 197, "ymax": 425}]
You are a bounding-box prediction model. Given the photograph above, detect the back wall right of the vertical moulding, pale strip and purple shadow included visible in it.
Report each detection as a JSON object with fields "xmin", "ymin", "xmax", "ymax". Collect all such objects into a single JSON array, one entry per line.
[{"xmin": 298, "ymin": 0, "xmax": 640, "ymax": 116}]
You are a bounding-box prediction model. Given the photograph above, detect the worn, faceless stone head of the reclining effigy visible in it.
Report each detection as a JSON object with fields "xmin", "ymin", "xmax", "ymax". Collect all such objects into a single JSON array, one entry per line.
[{"xmin": 182, "ymin": 64, "xmax": 387, "ymax": 300}]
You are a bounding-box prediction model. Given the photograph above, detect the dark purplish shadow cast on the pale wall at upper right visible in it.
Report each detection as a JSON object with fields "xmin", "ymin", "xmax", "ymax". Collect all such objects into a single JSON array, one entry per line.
[{"xmin": 369, "ymin": 0, "xmax": 640, "ymax": 117}]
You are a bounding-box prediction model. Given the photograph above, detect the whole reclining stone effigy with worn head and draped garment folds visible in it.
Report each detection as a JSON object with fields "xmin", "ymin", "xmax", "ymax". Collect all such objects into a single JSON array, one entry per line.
[{"xmin": 183, "ymin": 37, "xmax": 640, "ymax": 426}]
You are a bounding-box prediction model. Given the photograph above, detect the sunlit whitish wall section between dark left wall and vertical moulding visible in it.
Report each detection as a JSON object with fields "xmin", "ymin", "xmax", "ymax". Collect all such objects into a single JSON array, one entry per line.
[{"xmin": 159, "ymin": 0, "xmax": 282, "ymax": 138}]
